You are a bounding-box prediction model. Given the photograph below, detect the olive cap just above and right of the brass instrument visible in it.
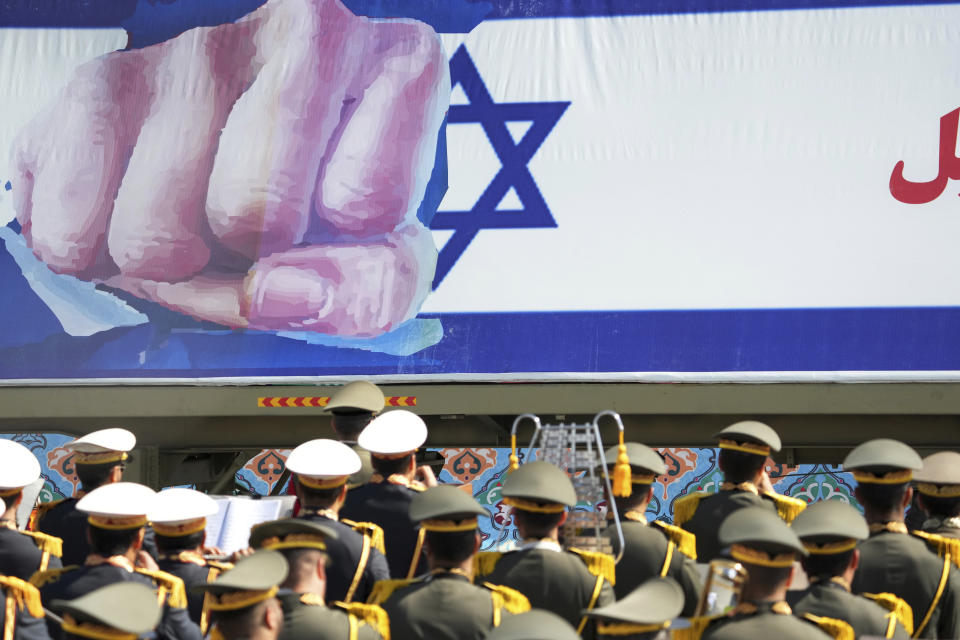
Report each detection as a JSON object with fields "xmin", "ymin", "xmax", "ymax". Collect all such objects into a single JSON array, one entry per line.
[{"xmin": 718, "ymin": 507, "xmax": 807, "ymax": 567}]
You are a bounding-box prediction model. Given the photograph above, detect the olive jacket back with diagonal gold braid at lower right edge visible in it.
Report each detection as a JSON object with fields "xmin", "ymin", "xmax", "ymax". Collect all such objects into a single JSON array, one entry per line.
[{"xmin": 851, "ymin": 530, "xmax": 960, "ymax": 638}]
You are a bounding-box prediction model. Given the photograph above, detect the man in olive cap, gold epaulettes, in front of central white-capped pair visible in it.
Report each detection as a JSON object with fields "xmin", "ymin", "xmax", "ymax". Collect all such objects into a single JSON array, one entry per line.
[{"xmin": 371, "ymin": 485, "xmax": 530, "ymax": 640}]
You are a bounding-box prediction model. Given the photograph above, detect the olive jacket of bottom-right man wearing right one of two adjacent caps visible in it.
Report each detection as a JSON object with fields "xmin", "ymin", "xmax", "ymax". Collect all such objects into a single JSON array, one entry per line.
[{"xmin": 787, "ymin": 580, "xmax": 910, "ymax": 638}]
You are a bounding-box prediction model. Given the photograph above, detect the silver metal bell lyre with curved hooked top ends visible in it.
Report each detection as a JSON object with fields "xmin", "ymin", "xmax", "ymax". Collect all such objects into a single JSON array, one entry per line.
[{"xmin": 510, "ymin": 411, "xmax": 624, "ymax": 561}]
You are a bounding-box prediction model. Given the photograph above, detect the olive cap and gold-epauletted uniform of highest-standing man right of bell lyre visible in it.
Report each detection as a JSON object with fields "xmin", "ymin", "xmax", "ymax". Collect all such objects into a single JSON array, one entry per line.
[{"xmin": 673, "ymin": 420, "xmax": 806, "ymax": 562}]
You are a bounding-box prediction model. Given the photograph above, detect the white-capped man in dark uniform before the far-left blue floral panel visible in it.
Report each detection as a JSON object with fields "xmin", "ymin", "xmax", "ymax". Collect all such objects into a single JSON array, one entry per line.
[{"xmin": 36, "ymin": 427, "xmax": 155, "ymax": 565}]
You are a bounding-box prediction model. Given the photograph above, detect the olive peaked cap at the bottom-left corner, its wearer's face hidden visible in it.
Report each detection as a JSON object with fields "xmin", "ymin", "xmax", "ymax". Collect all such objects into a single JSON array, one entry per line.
[{"xmin": 50, "ymin": 581, "xmax": 163, "ymax": 636}]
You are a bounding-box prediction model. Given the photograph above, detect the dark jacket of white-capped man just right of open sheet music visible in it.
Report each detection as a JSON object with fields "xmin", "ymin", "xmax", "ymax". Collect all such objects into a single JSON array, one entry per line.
[{"xmin": 298, "ymin": 509, "xmax": 390, "ymax": 602}]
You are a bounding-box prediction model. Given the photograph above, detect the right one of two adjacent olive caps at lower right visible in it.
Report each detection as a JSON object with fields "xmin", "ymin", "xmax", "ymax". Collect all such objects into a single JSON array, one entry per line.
[{"xmin": 790, "ymin": 500, "xmax": 870, "ymax": 555}]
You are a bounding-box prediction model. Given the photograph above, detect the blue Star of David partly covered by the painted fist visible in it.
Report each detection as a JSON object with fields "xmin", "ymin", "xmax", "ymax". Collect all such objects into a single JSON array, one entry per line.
[{"xmin": 430, "ymin": 45, "xmax": 570, "ymax": 288}]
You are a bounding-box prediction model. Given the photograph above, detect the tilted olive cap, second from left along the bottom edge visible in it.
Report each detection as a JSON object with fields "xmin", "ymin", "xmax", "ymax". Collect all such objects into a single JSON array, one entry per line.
[{"xmin": 193, "ymin": 549, "xmax": 289, "ymax": 611}]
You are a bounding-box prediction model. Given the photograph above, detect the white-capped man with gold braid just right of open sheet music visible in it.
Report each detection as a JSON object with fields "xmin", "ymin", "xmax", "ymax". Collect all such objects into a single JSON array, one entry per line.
[{"xmin": 287, "ymin": 439, "xmax": 390, "ymax": 602}]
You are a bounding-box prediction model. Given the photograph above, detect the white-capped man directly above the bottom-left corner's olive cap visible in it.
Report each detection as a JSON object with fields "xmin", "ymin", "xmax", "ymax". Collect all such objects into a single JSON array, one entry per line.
[{"xmin": 31, "ymin": 482, "xmax": 201, "ymax": 640}]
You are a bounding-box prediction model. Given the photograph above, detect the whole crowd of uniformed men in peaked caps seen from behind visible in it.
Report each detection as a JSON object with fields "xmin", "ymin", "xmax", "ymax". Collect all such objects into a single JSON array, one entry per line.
[{"xmin": 0, "ymin": 383, "xmax": 960, "ymax": 640}]
